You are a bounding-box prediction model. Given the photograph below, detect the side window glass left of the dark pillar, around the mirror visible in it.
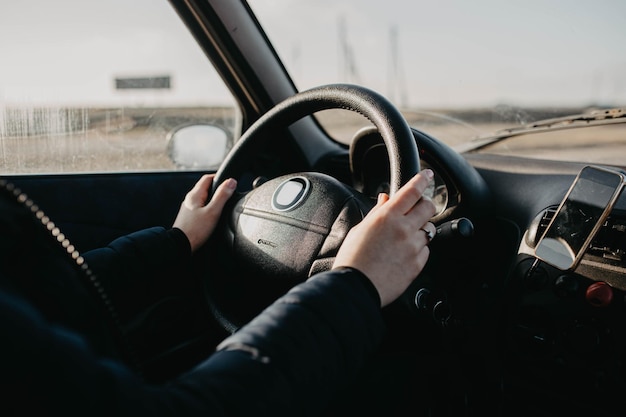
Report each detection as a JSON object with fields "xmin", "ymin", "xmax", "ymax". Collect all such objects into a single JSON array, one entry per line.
[{"xmin": 0, "ymin": 0, "xmax": 239, "ymax": 174}]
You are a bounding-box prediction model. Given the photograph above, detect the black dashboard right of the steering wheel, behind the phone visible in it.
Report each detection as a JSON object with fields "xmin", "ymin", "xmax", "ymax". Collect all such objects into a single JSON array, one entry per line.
[{"xmin": 350, "ymin": 126, "xmax": 626, "ymax": 415}]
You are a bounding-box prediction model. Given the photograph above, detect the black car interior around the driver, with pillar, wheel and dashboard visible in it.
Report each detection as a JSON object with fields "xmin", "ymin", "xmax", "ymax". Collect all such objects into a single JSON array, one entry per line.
[{"xmin": 0, "ymin": 0, "xmax": 626, "ymax": 416}]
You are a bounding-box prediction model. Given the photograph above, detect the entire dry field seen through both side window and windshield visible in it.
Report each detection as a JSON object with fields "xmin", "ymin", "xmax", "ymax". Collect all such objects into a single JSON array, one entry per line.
[{"xmin": 0, "ymin": 107, "xmax": 626, "ymax": 174}]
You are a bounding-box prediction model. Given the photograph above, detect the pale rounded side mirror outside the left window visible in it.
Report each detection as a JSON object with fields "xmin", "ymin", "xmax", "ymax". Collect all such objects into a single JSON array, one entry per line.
[{"xmin": 167, "ymin": 124, "xmax": 231, "ymax": 169}]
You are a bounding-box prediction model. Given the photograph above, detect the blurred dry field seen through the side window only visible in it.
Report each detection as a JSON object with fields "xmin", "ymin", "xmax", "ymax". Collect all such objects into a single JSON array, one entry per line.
[{"xmin": 0, "ymin": 107, "xmax": 237, "ymax": 174}]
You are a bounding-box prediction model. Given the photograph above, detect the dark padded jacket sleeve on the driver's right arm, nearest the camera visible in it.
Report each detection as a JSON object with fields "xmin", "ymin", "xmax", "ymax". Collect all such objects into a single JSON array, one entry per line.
[{"xmin": 176, "ymin": 269, "xmax": 384, "ymax": 416}]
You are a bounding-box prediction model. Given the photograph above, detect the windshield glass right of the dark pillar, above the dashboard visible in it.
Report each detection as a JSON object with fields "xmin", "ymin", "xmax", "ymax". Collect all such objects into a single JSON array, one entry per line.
[{"xmin": 249, "ymin": 0, "xmax": 626, "ymax": 162}]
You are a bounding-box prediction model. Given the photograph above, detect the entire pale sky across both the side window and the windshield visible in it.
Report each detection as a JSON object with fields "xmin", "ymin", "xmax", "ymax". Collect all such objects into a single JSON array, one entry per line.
[{"xmin": 0, "ymin": 0, "xmax": 626, "ymax": 107}]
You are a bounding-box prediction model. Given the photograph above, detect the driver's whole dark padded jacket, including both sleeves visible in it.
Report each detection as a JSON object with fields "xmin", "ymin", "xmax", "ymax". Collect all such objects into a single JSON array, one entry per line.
[{"xmin": 0, "ymin": 188, "xmax": 383, "ymax": 416}]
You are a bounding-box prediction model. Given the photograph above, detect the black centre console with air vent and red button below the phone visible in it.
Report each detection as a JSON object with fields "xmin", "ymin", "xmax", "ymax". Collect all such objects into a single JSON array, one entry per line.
[{"xmin": 506, "ymin": 185, "xmax": 626, "ymax": 413}]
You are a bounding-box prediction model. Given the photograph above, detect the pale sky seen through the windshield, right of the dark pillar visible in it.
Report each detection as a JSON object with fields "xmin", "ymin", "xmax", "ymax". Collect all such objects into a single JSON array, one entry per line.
[{"xmin": 251, "ymin": 0, "xmax": 626, "ymax": 106}]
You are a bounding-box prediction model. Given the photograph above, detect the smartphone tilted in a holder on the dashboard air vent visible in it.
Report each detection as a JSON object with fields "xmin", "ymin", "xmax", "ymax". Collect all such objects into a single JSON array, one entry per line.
[{"xmin": 535, "ymin": 166, "xmax": 626, "ymax": 270}]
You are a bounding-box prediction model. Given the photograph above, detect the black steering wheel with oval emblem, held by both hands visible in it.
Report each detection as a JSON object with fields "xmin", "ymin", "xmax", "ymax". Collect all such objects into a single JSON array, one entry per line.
[{"xmin": 205, "ymin": 84, "xmax": 420, "ymax": 332}]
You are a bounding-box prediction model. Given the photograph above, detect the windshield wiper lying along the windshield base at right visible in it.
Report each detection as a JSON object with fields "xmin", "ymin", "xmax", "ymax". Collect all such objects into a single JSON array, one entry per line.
[{"xmin": 455, "ymin": 108, "xmax": 626, "ymax": 153}]
